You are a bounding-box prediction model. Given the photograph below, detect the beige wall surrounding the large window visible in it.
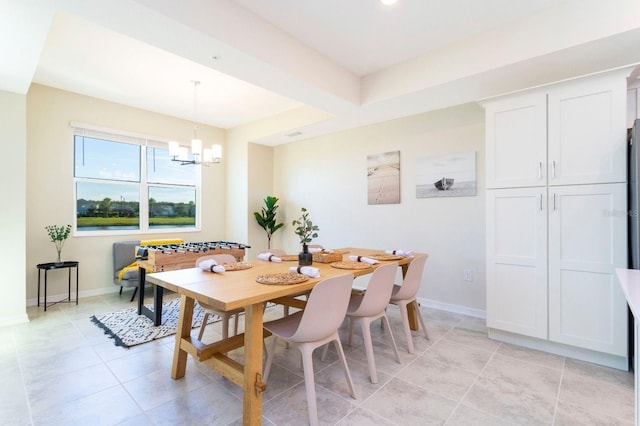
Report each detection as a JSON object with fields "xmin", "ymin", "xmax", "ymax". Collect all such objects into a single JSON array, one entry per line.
[{"xmin": 25, "ymin": 85, "xmax": 233, "ymax": 304}]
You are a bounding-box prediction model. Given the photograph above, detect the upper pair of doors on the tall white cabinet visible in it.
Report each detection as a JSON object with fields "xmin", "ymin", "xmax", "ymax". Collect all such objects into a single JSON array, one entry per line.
[{"xmin": 483, "ymin": 72, "xmax": 627, "ymax": 188}]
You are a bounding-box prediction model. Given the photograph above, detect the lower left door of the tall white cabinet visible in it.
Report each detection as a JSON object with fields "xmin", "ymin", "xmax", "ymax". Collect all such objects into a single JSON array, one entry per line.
[{"xmin": 486, "ymin": 188, "xmax": 547, "ymax": 339}]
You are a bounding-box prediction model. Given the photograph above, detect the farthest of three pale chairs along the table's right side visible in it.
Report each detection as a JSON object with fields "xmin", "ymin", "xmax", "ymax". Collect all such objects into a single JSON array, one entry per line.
[{"xmin": 389, "ymin": 255, "xmax": 429, "ymax": 354}]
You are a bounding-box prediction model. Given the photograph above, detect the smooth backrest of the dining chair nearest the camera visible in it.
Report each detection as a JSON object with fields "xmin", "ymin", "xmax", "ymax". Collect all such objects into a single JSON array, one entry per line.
[{"xmin": 289, "ymin": 274, "xmax": 353, "ymax": 342}]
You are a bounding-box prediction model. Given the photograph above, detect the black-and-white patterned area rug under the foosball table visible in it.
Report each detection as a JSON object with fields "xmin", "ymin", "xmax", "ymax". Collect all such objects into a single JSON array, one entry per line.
[{"xmin": 91, "ymin": 299, "xmax": 220, "ymax": 348}]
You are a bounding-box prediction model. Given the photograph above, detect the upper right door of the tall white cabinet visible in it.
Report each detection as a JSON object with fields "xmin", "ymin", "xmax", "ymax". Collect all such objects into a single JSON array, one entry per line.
[{"xmin": 548, "ymin": 73, "xmax": 627, "ymax": 185}]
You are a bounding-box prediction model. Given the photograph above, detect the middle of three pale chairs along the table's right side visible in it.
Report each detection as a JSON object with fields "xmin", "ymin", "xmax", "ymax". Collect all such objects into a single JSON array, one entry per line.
[{"xmin": 347, "ymin": 262, "xmax": 400, "ymax": 383}]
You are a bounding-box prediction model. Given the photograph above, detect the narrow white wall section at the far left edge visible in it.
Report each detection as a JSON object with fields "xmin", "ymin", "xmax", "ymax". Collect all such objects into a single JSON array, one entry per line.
[{"xmin": 0, "ymin": 91, "xmax": 28, "ymax": 327}]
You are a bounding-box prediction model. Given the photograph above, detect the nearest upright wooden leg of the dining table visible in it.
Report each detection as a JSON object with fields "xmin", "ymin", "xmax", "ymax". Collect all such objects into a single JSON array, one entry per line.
[{"xmin": 242, "ymin": 303, "xmax": 266, "ymax": 426}]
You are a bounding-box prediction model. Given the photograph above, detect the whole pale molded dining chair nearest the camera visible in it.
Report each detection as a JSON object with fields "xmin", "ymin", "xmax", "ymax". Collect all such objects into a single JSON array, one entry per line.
[{"xmin": 263, "ymin": 274, "xmax": 356, "ymax": 425}]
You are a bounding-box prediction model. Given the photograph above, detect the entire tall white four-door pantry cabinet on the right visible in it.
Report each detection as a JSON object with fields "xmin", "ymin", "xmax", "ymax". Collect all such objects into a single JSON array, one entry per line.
[{"xmin": 483, "ymin": 71, "xmax": 627, "ymax": 368}]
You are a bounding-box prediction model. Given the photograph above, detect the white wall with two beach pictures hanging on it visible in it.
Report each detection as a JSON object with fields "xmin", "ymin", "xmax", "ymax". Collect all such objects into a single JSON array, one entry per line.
[{"xmin": 273, "ymin": 104, "xmax": 485, "ymax": 315}]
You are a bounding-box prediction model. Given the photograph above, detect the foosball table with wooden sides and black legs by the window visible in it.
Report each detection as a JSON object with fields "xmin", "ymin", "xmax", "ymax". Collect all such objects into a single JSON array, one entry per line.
[{"xmin": 136, "ymin": 241, "xmax": 251, "ymax": 326}]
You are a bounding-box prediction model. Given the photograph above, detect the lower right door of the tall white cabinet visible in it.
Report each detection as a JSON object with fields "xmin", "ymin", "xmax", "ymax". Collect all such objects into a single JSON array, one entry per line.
[{"xmin": 549, "ymin": 184, "xmax": 627, "ymax": 356}]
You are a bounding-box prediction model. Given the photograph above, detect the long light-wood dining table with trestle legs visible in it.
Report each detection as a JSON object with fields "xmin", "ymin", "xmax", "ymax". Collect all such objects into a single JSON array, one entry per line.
[{"xmin": 146, "ymin": 248, "xmax": 419, "ymax": 425}]
